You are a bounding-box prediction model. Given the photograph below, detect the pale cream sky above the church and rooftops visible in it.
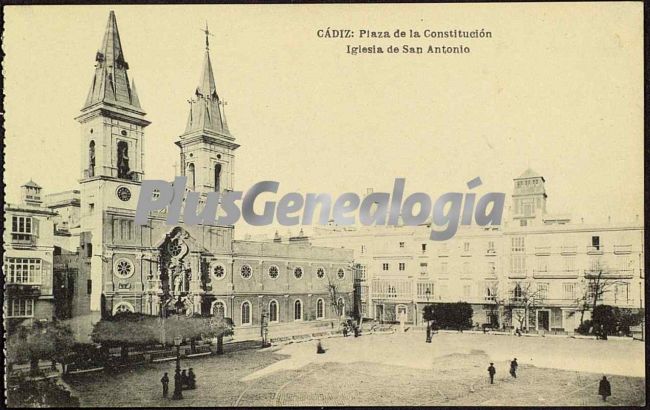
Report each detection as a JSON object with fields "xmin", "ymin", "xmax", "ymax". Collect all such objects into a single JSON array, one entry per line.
[{"xmin": 3, "ymin": 3, "xmax": 643, "ymax": 234}]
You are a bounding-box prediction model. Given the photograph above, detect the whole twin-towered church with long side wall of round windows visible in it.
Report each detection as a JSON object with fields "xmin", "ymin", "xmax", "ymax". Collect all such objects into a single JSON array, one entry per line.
[{"xmin": 60, "ymin": 11, "xmax": 353, "ymax": 334}]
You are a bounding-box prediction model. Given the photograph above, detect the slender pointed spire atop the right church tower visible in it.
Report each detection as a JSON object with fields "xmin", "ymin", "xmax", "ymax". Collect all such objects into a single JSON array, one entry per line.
[{"xmin": 185, "ymin": 28, "xmax": 230, "ymax": 135}]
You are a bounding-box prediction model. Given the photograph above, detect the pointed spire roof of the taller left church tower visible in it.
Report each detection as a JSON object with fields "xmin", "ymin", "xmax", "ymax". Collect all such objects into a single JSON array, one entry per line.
[{"xmin": 83, "ymin": 10, "xmax": 142, "ymax": 112}]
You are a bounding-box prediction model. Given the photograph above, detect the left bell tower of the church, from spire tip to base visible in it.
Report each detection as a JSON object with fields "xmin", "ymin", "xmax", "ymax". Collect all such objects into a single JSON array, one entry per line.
[{"xmin": 75, "ymin": 11, "xmax": 150, "ymax": 312}]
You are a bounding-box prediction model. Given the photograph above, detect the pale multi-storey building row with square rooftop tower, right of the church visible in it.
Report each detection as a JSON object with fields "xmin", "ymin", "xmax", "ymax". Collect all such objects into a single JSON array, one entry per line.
[{"xmin": 309, "ymin": 170, "xmax": 645, "ymax": 331}]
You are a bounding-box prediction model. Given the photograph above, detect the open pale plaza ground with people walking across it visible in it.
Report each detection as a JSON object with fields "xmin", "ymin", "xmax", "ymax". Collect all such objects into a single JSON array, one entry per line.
[{"xmin": 60, "ymin": 332, "xmax": 645, "ymax": 407}]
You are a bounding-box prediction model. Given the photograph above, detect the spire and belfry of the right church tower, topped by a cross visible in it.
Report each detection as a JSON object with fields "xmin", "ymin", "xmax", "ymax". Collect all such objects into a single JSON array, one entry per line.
[{"xmin": 176, "ymin": 24, "xmax": 239, "ymax": 193}]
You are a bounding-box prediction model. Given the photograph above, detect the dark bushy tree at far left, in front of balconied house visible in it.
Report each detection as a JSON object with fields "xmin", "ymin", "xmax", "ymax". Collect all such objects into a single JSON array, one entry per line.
[{"xmin": 7, "ymin": 322, "xmax": 75, "ymax": 374}]
